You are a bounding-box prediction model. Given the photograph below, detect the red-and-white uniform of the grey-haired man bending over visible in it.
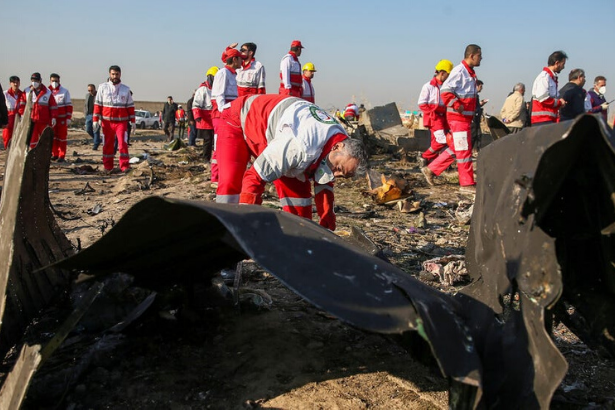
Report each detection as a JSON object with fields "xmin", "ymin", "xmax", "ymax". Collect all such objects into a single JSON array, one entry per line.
[{"xmin": 216, "ymin": 95, "xmax": 348, "ymax": 230}]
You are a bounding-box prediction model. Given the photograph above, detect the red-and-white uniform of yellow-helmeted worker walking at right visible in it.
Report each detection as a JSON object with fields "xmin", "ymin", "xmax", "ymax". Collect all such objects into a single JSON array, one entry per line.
[{"xmin": 418, "ymin": 77, "xmax": 452, "ymax": 164}]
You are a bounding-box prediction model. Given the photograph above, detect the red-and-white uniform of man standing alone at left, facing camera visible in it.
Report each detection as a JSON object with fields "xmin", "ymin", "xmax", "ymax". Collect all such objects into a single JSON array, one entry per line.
[{"xmin": 92, "ymin": 81, "xmax": 136, "ymax": 171}]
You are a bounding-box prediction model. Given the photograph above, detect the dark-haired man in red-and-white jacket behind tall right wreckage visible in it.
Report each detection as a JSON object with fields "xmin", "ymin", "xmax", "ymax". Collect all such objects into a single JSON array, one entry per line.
[{"xmin": 531, "ymin": 51, "xmax": 568, "ymax": 125}]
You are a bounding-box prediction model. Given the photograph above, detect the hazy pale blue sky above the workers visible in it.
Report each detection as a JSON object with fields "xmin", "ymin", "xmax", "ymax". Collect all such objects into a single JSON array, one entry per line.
[{"xmin": 0, "ymin": 0, "xmax": 615, "ymax": 118}]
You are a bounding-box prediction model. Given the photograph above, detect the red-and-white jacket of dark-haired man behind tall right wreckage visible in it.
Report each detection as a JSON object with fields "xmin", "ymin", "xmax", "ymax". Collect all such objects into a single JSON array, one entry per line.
[{"xmin": 532, "ymin": 67, "xmax": 561, "ymax": 124}]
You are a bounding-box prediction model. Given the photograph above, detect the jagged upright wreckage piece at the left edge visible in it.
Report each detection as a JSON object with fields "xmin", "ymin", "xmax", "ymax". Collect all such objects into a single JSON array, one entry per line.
[{"xmin": 0, "ymin": 97, "xmax": 74, "ymax": 409}]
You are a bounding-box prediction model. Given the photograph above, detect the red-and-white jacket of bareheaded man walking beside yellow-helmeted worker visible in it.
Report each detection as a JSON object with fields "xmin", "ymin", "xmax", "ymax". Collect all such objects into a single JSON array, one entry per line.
[{"xmin": 440, "ymin": 61, "xmax": 476, "ymax": 123}]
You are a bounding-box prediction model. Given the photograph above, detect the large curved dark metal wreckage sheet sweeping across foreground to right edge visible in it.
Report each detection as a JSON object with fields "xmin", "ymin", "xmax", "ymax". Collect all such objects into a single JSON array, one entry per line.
[{"xmin": 0, "ymin": 111, "xmax": 615, "ymax": 409}]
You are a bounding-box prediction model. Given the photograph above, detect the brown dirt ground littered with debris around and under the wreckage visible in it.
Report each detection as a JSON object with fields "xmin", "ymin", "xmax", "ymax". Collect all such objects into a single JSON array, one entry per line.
[{"xmin": 0, "ymin": 126, "xmax": 615, "ymax": 409}]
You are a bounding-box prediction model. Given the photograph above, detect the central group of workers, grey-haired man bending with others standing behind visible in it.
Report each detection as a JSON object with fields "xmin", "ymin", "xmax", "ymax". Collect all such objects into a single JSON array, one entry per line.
[{"xmin": 192, "ymin": 40, "xmax": 367, "ymax": 230}]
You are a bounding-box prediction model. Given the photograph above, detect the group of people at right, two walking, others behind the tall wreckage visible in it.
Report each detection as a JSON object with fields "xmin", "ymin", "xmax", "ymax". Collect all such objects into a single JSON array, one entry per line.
[{"xmin": 418, "ymin": 44, "xmax": 615, "ymax": 193}]
